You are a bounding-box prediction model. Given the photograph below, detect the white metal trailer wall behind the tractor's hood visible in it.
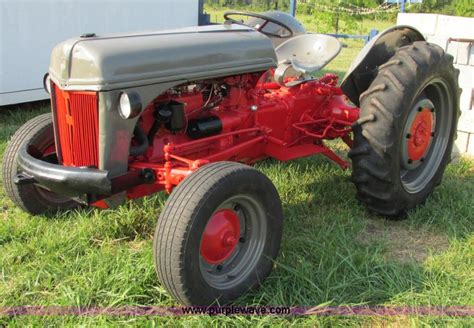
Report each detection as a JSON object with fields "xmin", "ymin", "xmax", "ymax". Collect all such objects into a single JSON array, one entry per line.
[{"xmin": 0, "ymin": 0, "xmax": 199, "ymax": 105}]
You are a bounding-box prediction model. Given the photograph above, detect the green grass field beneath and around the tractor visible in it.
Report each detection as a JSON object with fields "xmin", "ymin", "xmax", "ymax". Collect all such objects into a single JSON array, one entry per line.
[{"xmin": 0, "ymin": 14, "xmax": 474, "ymax": 327}]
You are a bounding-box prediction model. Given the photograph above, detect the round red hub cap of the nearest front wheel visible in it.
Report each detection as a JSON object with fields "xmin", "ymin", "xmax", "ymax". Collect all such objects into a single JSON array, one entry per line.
[{"xmin": 200, "ymin": 209, "xmax": 240, "ymax": 264}]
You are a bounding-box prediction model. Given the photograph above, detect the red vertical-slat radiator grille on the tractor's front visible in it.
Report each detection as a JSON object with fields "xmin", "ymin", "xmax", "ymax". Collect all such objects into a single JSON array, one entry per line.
[{"xmin": 54, "ymin": 85, "xmax": 99, "ymax": 167}]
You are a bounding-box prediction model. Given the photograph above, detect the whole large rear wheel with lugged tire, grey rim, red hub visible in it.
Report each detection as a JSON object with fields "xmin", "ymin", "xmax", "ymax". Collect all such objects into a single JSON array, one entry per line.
[{"xmin": 349, "ymin": 42, "xmax": 459, "ymax": 218}]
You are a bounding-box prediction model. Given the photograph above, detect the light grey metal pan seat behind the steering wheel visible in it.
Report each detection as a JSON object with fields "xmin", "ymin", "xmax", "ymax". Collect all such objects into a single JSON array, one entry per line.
[{"xmin": 275, "ymin": 34, "xmax": 341, "ymax": 74}]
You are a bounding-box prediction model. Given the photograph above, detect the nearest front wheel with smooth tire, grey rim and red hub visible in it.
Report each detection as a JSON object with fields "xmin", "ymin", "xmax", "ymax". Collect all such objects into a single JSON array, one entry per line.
[{"xmin": 154, "ymin": 162, "xmax": 283, "ymax": 305}]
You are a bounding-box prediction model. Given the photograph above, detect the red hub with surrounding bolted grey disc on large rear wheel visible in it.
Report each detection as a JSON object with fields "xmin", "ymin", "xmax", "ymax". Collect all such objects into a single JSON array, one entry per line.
[{"xmin": 402, "ymin": 99, "xmax": 435, "ymax": 169}]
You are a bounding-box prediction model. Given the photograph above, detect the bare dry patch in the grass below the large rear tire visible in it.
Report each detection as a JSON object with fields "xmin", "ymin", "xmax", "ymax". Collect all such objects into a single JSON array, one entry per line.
[{"xmin": 358, "ymin": 218, "xmax": 449, "ymax": 263}]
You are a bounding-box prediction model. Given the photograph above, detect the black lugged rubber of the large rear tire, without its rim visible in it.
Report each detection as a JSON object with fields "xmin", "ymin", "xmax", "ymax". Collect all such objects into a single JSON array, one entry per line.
[{"xmin": 349, "ymin": 41, "xmax": 460, "ymax": 218}]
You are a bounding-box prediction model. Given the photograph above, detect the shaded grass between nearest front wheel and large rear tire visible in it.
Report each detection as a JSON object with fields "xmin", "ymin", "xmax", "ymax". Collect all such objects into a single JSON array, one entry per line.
[{"xmin": 239, "ymin": 158, "xmax": 473, "ymax": 306}]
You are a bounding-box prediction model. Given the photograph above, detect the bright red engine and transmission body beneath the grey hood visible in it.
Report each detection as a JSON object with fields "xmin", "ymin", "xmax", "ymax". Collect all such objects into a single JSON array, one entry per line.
[{"xmin": 117, "ymin": 71, "xmax": 359, "ymax": 202}]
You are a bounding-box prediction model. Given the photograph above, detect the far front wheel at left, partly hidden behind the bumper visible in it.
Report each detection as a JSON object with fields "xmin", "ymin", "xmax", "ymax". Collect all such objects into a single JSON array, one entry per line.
[{"xmin": 2, "ymin": 113, "xmax": 78, "ymax": 215}]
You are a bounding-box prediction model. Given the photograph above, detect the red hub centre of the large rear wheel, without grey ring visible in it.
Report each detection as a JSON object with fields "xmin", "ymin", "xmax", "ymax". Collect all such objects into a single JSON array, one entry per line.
[{"xmin": 407, "ymin": 108, "xmax": 433, "ymax": 161}]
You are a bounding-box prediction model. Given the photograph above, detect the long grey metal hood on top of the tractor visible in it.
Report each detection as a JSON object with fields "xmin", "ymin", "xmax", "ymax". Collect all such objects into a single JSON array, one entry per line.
[{"xmin": 49, "ymin": 25, "xmax": 277, "ymax": 91}]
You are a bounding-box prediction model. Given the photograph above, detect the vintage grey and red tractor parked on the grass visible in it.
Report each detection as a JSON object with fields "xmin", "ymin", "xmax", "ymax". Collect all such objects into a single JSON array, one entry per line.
[{"xmin": 3, "ymin": 11, "xmax": 460, "ymax": 305}]
